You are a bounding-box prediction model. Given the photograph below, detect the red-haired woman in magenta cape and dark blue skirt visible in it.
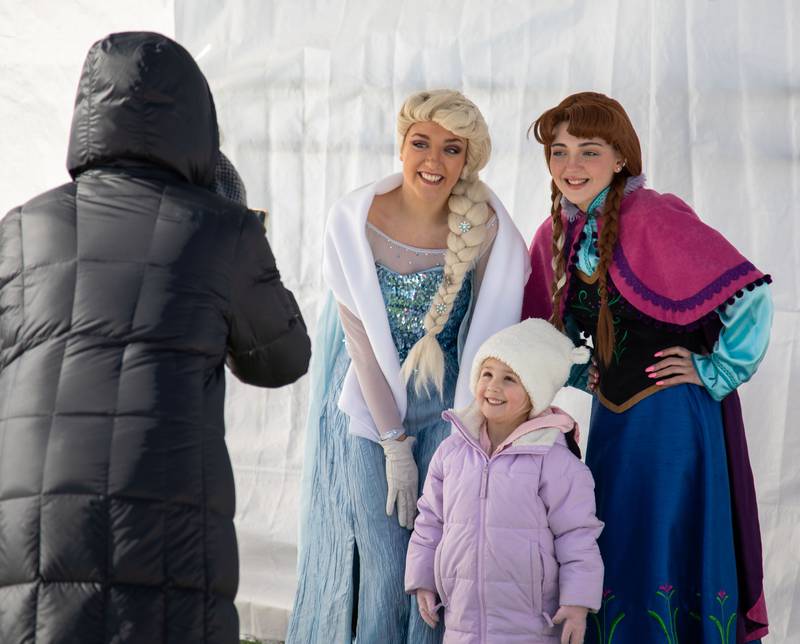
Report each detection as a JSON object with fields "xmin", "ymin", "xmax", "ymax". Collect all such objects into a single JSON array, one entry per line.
[{"xmin": 523, "ymin": 92, "xmax": 772, "ymax": 644}]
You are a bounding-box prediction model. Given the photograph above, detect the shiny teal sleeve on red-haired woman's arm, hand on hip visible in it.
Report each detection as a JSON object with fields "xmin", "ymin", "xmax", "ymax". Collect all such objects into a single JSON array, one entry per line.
[{"xmin": 692, "ymin": 284, "xmax": 773, "ymax": 400}]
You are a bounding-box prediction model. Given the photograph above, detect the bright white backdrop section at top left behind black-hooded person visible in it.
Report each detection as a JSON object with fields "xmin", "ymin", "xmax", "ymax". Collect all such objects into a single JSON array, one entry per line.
[{"xmin": 0, "ymin": 0, "xmax": 175, "ymax": 209}]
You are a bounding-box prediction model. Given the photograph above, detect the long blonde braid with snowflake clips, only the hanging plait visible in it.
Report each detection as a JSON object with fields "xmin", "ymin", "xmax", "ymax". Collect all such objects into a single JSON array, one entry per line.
[{"xmin": 400, "ymin": 173, "xmax": 490, "ymax": 395}]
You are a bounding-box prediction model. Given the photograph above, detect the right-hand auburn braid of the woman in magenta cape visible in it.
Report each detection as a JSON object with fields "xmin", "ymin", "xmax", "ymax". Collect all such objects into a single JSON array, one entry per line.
[{"xmin": 597, "ymin": 175, "xmax": 625, "ymax": 366}]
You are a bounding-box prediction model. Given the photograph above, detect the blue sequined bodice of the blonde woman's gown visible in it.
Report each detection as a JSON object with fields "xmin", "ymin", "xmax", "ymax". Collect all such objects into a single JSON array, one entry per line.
[{"xmin": 375, "ymin": 263, "xmax": 472, "ymax": 362}]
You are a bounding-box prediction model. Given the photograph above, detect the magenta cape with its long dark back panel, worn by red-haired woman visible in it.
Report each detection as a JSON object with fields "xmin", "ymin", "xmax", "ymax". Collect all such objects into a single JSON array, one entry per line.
[{"xmin": 522, "ymin": 188, "xmax": 770, "ymax": 643}]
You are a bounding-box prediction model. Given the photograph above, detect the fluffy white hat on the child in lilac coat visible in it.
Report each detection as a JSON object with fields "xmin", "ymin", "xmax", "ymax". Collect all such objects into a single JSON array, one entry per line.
[{"xmin": 470, "ymin": 318, "xmax": 591, "ymax": 418}]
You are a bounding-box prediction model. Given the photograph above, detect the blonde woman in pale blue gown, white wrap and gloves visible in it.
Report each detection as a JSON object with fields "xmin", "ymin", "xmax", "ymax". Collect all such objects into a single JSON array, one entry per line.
[{"xmin": 287, "ymin": 90, "xmax": 528, "ymax": 644}]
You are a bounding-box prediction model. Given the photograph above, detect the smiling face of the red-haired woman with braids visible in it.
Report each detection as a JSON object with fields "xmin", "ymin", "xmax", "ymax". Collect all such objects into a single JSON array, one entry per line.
[{"xmin": 548, "ymin": 121, "xmax": 624, "ymax": 212}]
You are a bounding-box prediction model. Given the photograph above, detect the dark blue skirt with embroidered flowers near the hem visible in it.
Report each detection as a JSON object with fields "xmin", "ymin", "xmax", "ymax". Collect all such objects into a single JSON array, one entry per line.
[{"xmin": 586, "ymin": 385, "xmax": 737, "ymax": 644}]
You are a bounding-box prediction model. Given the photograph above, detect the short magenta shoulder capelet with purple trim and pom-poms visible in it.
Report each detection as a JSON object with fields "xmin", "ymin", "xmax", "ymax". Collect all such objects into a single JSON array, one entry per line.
[{"xmin": 523, "ymin": 188, "xmax": 766, "ymax": 326}]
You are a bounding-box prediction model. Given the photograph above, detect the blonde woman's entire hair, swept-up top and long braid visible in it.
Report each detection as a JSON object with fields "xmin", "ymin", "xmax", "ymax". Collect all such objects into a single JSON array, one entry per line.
[{"xmin": 397, "ymin": 89, "xmax": 492, "ymax": 395}]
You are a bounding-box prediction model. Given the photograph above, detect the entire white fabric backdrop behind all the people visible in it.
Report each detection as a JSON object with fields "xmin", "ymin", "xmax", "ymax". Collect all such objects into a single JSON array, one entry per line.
[{"xmin": 0, "ymin": 0, "xmax": 800, "ymax": 643}]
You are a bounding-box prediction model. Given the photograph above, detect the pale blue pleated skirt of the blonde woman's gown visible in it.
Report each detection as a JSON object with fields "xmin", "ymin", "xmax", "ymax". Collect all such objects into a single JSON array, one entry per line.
[{"xmin": 287, "ymin": 343, "xmax": 450, "ymax": 644}]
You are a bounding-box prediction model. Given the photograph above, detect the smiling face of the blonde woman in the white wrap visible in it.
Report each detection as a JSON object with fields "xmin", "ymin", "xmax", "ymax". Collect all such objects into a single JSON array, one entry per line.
[{"xmin": 400, "ymin": 121, "xmax": 467, "ymax": 201}]
